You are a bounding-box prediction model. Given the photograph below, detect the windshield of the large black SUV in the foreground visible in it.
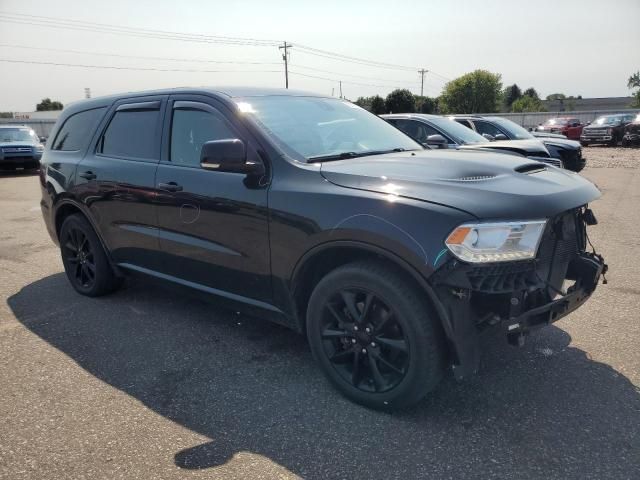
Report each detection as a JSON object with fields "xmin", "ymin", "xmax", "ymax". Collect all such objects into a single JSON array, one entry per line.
[{"xmin": 236, "ymin": 95, "xmax": 423, "ymax": 160}]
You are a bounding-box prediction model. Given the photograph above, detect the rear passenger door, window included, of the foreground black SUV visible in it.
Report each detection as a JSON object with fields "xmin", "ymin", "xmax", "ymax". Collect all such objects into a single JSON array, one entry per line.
[{"xmin": 77, "ymin": 96, "xmax": 167, "ymax": 270}]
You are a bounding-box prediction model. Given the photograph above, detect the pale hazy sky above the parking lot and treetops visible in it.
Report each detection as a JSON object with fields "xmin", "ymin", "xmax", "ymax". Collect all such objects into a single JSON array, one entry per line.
[{"xmin": 0, "ymin": 0, "xmax": 640, "ymax": 111}]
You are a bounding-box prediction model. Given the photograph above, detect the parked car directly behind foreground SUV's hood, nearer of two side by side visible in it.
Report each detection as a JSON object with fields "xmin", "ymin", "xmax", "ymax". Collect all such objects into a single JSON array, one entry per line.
[{"xmin": 381, "ymin": 113, "xmax": 562, "ymax": 167}]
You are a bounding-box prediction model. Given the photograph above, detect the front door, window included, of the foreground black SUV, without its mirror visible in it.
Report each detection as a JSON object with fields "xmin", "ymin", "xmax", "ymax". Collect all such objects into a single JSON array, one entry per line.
[{"xmin": 156, "ymin": 95, "xmax": 271, "ymax": 302}]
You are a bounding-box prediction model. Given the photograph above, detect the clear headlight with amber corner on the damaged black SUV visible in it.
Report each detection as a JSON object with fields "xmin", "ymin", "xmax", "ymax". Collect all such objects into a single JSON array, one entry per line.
[{"xmin": 445, "ymin": 220, "xmax": 547, "ymax": 263}]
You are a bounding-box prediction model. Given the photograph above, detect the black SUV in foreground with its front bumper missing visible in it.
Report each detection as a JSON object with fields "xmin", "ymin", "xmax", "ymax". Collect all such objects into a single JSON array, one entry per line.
[{"xmin": 40, "ymin": 89, "xmax": 605, "ymax": 408}]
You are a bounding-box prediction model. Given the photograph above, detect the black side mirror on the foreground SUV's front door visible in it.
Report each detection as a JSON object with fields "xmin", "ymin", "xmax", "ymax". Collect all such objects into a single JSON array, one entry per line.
[{"xmin": 200, "ymin": 138, "xmax": 263, "ymax": 174}]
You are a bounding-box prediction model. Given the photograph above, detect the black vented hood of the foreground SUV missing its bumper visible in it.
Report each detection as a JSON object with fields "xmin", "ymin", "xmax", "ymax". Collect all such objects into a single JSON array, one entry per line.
[{"xmin": 320, "ymin": 150, "xmax": 600, "ymax": 221}]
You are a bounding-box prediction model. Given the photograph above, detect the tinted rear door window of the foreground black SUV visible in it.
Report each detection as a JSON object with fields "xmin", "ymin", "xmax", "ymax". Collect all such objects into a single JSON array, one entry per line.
[{"xmin": 100, "ymin": 110, "xmax": 160, "ymax": 158}]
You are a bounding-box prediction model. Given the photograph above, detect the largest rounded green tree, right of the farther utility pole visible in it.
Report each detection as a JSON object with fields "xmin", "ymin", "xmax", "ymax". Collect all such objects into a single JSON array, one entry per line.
[{"xmin": 438, "ymin": 70, "xmax": 502, "ymax": 113}]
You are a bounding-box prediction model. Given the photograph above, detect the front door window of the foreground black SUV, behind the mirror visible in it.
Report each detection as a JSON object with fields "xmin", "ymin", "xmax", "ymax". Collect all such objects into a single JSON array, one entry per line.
[{"xmin": 171, "ymin": 109, "xmax": 238, "ymax": 167}]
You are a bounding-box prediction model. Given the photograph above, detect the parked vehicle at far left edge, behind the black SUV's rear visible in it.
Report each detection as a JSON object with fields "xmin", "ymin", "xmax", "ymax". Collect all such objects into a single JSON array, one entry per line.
[{"xmin": 0, "ymin": 125, "xmax": 44, "ymax": 170}]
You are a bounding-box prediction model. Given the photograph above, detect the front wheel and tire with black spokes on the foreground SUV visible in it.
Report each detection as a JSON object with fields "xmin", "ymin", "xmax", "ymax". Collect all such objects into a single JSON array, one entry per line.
[{"xmin": 307, "ymin": 261, "xmax": 446, "ymax": 410}]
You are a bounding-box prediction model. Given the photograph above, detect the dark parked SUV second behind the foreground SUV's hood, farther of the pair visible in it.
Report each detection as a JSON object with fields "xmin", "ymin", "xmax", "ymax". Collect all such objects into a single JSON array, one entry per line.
[{"xmin": 451, "ymin": 115, "xmax": 586, "ymax": 172}]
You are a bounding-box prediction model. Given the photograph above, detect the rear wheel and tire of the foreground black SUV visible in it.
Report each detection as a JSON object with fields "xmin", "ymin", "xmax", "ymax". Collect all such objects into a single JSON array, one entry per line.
[{"xmin": 60, "ymin": 213, "xmax": 122, "ymax": 297}]
